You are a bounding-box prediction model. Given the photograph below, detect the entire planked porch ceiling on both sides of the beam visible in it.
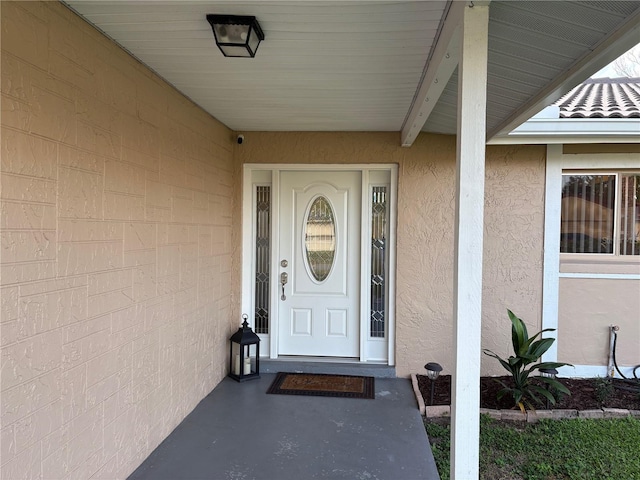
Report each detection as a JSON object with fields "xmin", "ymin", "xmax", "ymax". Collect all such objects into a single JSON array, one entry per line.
[{"xmin": 65, "ymin": 0, "xmax": 640, "ymax": 144}]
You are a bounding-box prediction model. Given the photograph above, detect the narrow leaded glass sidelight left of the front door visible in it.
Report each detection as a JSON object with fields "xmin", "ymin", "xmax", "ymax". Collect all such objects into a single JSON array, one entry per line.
[{"xmin": 254, "ymin": 186, "xmax": 271, "ymax": 334}]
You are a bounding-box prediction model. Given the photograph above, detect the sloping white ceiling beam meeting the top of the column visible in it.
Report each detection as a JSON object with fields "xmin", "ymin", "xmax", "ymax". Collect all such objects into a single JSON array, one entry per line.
[{"xmin": 400, "ymin": 2, "xmax": 467, "ymax": 147}]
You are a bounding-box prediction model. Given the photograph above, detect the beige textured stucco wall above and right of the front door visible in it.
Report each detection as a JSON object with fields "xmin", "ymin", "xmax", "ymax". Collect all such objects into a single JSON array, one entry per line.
[{"xmin": 234, "ymin": 132, "xmax": 545, "ymax": 376}]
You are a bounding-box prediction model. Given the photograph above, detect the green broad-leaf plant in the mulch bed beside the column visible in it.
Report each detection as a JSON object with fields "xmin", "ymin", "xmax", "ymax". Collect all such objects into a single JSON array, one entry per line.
[{"xmin": 483, "ymin": 310, "xmax": 571, "ymax": 413}]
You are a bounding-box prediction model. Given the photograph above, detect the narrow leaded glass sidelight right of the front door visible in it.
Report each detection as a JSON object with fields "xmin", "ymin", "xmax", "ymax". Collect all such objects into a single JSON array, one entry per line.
[{"xmin": 370, "ymin": 187, "xmax": 387, "ymax": 338}]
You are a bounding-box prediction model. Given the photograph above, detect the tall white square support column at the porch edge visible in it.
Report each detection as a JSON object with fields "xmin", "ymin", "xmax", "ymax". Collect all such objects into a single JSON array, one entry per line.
[{"xmin": 451, "ymin": 2, "xmax": 489, "ymax": 480}]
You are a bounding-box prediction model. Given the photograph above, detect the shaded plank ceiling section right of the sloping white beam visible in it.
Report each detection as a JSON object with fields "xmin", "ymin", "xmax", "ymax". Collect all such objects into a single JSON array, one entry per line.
[{"xmin": 422, "ymin": 0, "xmax": 640, "ymax": 138}]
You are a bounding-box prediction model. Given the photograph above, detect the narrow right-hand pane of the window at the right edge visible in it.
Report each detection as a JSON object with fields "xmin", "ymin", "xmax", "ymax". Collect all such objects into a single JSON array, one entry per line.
[{"xmin": 620, "ymin": 175, "xmax": 640, "ymax": 255}]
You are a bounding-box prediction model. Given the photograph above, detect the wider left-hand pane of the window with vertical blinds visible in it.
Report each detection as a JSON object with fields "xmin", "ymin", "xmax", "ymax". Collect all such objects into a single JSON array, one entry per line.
[{"xmin": 560, "ymin": 175, "xmax": 616, "ymax": 253}]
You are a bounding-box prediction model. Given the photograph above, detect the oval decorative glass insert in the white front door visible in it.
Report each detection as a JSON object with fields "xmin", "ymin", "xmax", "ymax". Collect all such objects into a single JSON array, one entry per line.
[{"xmin": 304, "ymin": 196, "xmax": 336, "ymax": 282}]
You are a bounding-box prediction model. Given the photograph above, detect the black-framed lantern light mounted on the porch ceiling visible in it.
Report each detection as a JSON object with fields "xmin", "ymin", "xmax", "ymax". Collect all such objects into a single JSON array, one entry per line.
[{"xmin": 207, "ymin": 15, "xmax": 264, "ymax": 58}]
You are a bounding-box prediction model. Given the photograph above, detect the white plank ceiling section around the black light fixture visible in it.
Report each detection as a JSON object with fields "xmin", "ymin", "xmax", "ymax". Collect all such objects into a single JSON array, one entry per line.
[{"xmin": 67, "ymin": 1, "xmax": 446, "ymax": 131}]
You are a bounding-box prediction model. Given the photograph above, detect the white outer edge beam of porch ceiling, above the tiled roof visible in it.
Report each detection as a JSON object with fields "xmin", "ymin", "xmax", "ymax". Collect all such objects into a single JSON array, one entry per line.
[{"xmin": 487, "ymin": 11, "xmax": 640, "ymax": 141}]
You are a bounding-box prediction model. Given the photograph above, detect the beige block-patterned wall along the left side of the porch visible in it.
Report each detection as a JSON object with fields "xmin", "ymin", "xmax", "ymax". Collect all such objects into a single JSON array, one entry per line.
[{"xmin": 0, "ymin": 1, "xmax": 238, "ymax": 479}]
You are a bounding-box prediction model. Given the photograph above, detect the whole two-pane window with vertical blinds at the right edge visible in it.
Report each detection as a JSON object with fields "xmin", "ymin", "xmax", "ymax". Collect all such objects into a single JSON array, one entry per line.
[{"xmin": 560, "ymin": 172, "xmax": 640, "ymax": 255}]
